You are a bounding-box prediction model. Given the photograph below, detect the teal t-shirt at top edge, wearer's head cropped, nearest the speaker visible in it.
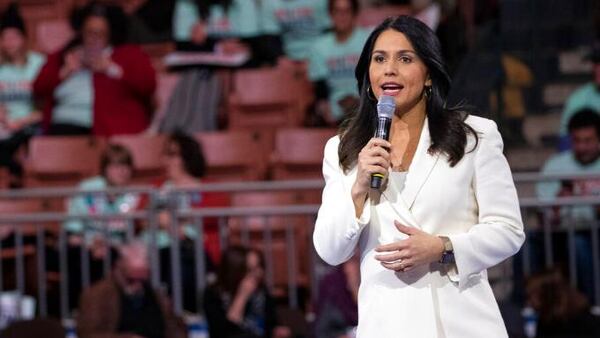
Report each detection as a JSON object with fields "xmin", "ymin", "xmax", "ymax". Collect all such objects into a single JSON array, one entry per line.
[{"xmin": 261, "ymin": 0, "xmax": 331, "ymax": 60}]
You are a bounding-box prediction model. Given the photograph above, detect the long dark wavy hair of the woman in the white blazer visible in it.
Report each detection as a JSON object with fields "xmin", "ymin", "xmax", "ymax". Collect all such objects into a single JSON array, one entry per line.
[{"xmin": 338, "ymin": 15, "xmax": 479, "ymax": 171}]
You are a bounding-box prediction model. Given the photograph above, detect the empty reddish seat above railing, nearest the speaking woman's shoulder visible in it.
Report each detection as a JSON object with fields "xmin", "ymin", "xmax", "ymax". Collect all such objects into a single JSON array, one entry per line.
[{"xmin": 271, "ymin": 128, "xmax": 337, "ymax": 180}]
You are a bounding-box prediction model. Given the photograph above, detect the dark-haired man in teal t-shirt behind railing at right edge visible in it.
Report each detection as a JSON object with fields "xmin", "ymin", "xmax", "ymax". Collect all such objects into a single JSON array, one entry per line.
[{"xmin": 536, "ymin": 109, "xmax": 600, "ymax": 297}]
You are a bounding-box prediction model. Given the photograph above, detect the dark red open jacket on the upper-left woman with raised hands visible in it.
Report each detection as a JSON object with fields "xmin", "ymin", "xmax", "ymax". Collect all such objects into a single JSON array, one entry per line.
[{"xmin": 33, "ymin": 45, "xmax": 156, "ymax": 136}]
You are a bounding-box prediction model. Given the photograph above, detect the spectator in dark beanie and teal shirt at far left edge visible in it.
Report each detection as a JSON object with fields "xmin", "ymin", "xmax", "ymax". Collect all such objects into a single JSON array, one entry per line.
[{"xmin": 0, "ymin": 3, "xmax": 44, "ymax": 187}]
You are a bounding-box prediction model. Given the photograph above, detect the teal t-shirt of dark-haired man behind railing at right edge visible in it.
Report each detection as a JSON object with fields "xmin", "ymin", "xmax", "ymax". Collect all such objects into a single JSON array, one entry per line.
[{"xmin": 536, "ymin": 151, "xmax": 600, "ymax": 226}]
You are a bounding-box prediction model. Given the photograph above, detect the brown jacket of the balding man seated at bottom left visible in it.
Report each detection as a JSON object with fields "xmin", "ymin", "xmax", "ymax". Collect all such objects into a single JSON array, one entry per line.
[{"xmin": 77, "ymin": 276, "xmax": 187, "ymax": 338}]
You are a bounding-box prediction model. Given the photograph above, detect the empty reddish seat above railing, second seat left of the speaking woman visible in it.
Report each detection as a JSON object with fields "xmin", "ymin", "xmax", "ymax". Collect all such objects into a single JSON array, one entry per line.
[{"xmin": 195, "ymin": 130, "xmax": 269, "ymax": 181}]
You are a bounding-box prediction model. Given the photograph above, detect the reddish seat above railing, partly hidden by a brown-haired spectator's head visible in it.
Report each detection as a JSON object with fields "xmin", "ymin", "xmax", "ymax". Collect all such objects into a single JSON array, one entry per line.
[{"xmin": 108, "ymin": 134, "xmax": 165, "ymax": 184}]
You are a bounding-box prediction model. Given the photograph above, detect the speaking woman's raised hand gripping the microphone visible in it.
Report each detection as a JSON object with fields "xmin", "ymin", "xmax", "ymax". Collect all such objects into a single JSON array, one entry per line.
[{"xmin": 351, "ymin": 137, "xmax": 392, "ymax": 217}]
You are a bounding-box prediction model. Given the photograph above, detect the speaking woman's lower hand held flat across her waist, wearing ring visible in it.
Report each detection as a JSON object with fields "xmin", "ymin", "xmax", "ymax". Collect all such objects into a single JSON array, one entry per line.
[{"xmin": 375, "ymin": 221, "xmax": 444, "ymax": 272}]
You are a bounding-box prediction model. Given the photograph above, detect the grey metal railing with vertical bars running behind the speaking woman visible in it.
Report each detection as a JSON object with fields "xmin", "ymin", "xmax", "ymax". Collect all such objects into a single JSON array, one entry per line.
[{"xmin": 0, "ymin": 173, "xmax": 600, "ymax": 318}]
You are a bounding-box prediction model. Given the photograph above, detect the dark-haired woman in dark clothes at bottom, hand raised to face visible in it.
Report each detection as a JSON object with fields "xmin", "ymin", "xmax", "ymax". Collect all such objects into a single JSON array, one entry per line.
[{"xmin": 203, "ymin": 247, "xmax": 290, "ymax": 338}]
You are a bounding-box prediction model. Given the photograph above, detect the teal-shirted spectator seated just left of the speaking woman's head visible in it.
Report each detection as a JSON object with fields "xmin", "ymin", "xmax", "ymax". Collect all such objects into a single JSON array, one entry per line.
[{"xmin": 308, "ymin": 0, "xmax": 369, "ymax": 126}]
